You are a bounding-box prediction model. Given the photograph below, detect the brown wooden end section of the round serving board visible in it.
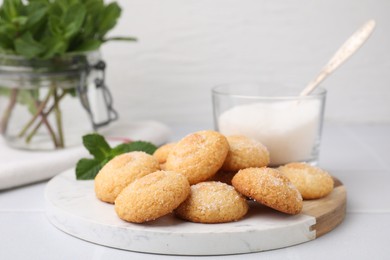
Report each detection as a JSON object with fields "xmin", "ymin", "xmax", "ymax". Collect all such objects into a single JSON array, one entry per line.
[{"xmin": 302, "ymin": 178, "xmax": 347, "ymax": 238}]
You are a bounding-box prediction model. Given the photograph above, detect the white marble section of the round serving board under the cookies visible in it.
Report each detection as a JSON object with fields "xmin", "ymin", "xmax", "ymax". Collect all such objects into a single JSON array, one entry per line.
[{"xmin": 45, "ymin": 169, "xmax": 316, "ymax": 255}]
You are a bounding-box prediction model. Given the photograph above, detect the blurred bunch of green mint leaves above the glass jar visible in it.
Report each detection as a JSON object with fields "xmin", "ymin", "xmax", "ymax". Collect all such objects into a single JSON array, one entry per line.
[{"xmin": 0, "ymin": 0, "xmax": 137, "ymax": 59}]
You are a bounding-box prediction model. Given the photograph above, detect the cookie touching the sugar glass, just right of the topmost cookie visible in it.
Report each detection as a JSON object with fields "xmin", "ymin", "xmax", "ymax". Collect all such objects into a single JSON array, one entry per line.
[{"xmin": 222, "ymin": 135, "xmax": 270, "ymax": 171}]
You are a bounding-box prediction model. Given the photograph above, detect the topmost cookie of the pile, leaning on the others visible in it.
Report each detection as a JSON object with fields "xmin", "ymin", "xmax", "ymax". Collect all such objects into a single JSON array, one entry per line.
[{"xmin": 165, "ymin": 130, "xmax": 229, "ymax": 184}]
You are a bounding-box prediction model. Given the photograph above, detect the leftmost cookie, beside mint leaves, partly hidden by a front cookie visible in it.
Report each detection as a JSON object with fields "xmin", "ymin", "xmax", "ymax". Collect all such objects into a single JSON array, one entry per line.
[{"xmin": 95, "ymin": 152, "xmax": 160, "ymax": 203}]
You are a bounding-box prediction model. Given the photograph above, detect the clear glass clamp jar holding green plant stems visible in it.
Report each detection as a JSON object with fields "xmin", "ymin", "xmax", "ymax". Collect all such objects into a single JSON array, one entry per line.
[{"xmin": 0, "ymin": 51, "xmax": 117, "ymax": 150}]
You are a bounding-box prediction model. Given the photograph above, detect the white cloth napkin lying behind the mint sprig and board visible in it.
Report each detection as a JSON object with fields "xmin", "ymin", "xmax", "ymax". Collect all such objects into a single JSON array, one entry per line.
[{"xmin": 0, "ymin": 121, "xmax": 171, "ymax": 190}]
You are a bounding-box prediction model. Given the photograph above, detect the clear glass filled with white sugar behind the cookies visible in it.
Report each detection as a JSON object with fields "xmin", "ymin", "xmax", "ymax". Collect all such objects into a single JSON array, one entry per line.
[{"xmin": 212, "ymin": 83, "xmax": 326, "ymax": 166}]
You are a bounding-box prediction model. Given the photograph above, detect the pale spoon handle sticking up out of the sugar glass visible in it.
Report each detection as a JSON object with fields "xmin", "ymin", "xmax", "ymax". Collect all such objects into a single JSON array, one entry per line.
[{"xmin": 300, "ymin": 20, "xmax": 375, "ymax": 96}]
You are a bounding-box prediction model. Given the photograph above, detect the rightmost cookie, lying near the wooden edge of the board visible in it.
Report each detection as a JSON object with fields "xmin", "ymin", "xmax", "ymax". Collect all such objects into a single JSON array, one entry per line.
[{"xmin": 278, "ymin": 163, "xmax": 334, "ymax": 199}]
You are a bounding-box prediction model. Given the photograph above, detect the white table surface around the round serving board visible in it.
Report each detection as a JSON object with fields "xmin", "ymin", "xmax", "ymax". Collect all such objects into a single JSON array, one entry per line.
[{"xmin": 0, "ymin": 124, "xmax": 390, "ymax": 260}]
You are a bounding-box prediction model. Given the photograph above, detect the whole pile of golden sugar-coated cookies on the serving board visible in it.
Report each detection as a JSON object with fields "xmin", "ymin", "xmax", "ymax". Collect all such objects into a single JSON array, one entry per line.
[{"xmin": 95, "ymin": 130, "xmax": 333, "ymax": 223}]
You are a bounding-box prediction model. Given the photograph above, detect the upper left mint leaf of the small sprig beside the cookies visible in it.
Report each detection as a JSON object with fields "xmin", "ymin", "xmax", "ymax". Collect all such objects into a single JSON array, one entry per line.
[{"xmin": 83, "ymin": 134, "xmax": 111, "ymax": 160}]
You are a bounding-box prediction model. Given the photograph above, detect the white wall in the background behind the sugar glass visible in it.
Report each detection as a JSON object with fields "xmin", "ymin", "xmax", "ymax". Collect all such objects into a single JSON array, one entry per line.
[{"xmin": 103, "ymin": 0, "xmax": 390, "ymax": 126}]
